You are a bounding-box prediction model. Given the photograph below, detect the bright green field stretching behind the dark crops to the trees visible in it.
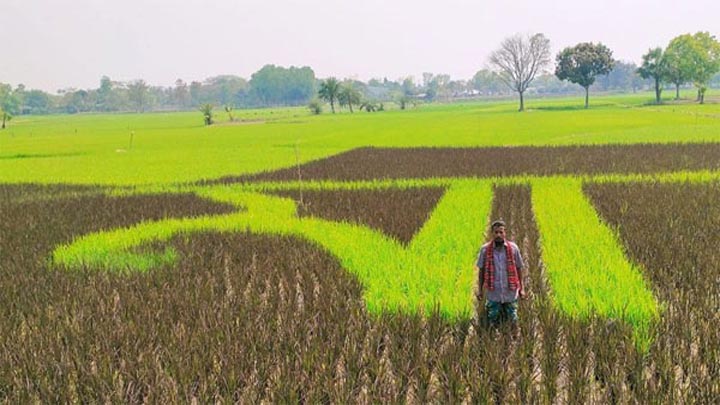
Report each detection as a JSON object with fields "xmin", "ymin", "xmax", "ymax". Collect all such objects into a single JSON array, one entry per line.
[{"xmin": 0, "ymin": 90, "xmax": 720, "ymax": 185}]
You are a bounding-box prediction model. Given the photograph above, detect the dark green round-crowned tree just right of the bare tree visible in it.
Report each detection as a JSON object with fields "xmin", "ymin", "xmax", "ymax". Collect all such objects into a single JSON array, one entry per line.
[{"xmin": 555, "ymin": 42, "xmax": 615, "ymax": 108}]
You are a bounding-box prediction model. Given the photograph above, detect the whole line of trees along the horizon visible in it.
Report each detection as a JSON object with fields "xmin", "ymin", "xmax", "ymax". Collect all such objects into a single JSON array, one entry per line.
[{"xmin": 0, "ymin": 32, "xmax": 720, "ymax": 128}]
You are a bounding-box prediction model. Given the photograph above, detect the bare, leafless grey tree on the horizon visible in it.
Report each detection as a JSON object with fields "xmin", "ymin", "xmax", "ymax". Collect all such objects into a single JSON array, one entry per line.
[{"xmin": 490, "ymin": 34, "xmax": 550, "ymax": 111}]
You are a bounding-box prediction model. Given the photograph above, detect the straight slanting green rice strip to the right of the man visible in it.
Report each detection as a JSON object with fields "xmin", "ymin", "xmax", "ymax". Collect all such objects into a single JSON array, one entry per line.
[{"xmin": 532, "ymin": 178, "xmax": 660, "ymax": 349}]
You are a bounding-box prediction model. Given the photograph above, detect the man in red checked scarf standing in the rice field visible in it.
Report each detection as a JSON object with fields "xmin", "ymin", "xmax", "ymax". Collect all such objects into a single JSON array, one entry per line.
[{"xmin": 475, "ymin": 220, "xmax": 525, "ymax": 328}]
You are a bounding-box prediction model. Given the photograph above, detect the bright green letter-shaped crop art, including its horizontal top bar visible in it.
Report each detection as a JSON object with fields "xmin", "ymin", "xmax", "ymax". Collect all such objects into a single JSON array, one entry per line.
[{"xmin": 53, "ymin": 145, "xmax": 717, "ymax": 342}]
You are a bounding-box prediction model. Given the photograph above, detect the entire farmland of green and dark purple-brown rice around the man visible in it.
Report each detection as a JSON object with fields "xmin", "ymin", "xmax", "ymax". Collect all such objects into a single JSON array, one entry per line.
[{"xmin": 0, "ymin": 96, "xmax": 720, "ymax": 403}]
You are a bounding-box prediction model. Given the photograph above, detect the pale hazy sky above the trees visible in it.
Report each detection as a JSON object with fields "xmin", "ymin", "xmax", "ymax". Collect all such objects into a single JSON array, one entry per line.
[{"xmin": 0, "ymin": 0, "xmax": 720, "ymax": 92}]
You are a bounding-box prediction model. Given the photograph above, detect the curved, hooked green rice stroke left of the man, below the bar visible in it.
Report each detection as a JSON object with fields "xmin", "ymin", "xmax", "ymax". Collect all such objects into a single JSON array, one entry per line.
[{"xmin": 53, "ymin": 180, "xmax": 492, "ymax": 317}]
